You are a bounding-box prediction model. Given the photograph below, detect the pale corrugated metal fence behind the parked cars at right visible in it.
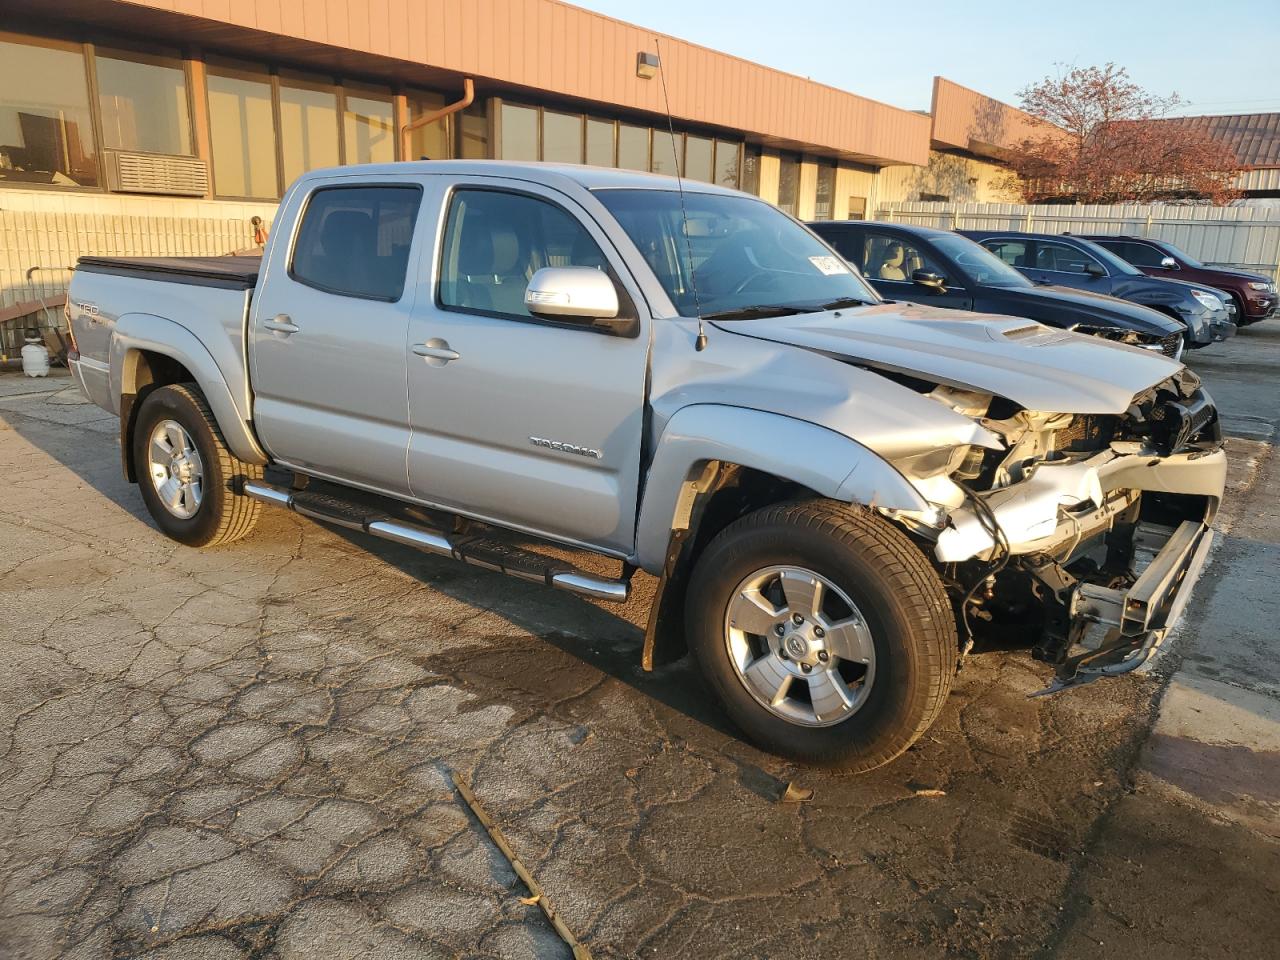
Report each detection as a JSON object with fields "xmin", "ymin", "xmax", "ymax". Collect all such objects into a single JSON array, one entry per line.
[{"xmin": 876, "ymin": 201, "xmax": 1280, "ymax": 279}]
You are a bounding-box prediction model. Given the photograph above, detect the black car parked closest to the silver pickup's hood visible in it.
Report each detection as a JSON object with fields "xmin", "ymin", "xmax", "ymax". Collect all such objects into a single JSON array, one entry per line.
[{"xmin": 809, "ymin": 220, "xmax": 1187, "ymax": 360}]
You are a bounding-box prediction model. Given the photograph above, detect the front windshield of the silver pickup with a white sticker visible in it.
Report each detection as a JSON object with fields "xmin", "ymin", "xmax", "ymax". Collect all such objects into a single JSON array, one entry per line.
[{"xmin": 596, "ymin": 189, "xmax": 879, "ymax": 319}]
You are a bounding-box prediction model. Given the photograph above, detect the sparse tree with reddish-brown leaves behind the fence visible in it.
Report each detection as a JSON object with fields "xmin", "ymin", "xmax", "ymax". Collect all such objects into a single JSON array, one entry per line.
[{"xmin": 1007, "ymin": 63, "xmax": 1242, "ymax": 204}]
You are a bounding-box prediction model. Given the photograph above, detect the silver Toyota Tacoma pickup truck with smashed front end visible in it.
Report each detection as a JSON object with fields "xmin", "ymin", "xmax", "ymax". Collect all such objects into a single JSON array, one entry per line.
[{"xmin": 68, "ymin": 161, "xmax": 1226, "ymax": 769}]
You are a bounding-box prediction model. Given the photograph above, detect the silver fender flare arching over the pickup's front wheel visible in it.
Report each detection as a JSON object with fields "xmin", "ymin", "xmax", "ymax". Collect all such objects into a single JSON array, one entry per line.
[{"xmin": 631, "ymin": 403, "xmax": 928, "ymax": 573}]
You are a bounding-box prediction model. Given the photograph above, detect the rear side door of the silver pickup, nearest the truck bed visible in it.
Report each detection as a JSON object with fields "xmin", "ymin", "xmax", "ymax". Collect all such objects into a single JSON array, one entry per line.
[{"xmin": 250, "ymin": 178, "xmax": 422, "ymax": 494}]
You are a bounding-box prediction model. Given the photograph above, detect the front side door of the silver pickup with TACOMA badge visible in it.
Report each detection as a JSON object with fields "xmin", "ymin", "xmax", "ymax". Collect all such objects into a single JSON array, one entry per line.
[{"xmin": 408, "ymin": 183, "xmax": 650, "ymax": 553}]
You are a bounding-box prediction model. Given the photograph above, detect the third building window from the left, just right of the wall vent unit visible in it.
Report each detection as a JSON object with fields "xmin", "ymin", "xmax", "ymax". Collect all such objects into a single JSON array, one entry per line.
[{"xmin": 207, "ymin": 64, "xmax": 280, "ymax": 198}]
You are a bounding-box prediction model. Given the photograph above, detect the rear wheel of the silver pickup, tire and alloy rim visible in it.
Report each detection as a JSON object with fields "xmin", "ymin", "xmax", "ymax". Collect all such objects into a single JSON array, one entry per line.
[{"xmin": 133, "ymin": 384, "xmax": 262, "ymax": 547}]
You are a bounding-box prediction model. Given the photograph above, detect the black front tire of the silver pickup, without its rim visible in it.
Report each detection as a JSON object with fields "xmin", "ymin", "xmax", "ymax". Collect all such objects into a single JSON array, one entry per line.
[{"xmin": 686, "ymin": 499, "xmax": 959, "ymax": 772}]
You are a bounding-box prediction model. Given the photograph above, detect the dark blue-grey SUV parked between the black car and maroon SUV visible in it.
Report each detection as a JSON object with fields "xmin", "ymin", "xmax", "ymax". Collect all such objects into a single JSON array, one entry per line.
[{"xmin": 959, "ymin": 230, "xmax": 1235, "ymax": 347}]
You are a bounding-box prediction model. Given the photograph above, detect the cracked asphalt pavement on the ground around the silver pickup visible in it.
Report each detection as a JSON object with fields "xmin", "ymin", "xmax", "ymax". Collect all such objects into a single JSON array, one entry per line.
[{"xmin": 0, "ymin": 321, "xmax": 1280, "ymax": 960}]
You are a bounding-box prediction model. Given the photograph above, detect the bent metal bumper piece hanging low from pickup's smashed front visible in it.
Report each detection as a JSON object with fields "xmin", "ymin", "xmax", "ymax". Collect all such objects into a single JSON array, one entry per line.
[{"xmin": 1033, "ymin": 520, "xmax": 1213, "ymax": 696}]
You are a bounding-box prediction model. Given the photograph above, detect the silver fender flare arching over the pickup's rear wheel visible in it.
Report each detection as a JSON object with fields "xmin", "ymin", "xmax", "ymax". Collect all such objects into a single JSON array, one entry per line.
[{"xmin": 109, "ymin": 314, "xmax": 268, "ymax": 463}]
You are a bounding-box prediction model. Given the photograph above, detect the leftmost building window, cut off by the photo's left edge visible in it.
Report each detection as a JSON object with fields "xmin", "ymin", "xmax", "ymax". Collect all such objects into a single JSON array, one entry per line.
[{"xmin": 0, "ymin": 40, "xmax": 97, "ymax": 187}]
